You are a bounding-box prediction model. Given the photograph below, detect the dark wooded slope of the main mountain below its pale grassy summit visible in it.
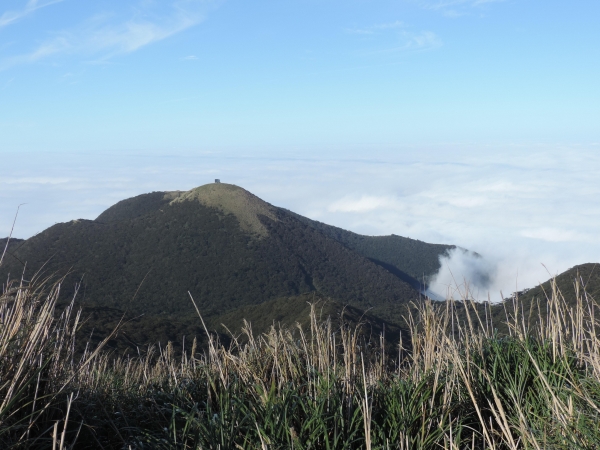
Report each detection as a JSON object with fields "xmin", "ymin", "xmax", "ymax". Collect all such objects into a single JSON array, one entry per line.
[{"xmin": 5, "ymin": 202, "xmax": 418, "ymax": 315}]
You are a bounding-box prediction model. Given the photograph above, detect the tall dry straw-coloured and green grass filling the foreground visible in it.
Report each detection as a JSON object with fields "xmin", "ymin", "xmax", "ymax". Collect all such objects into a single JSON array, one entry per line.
[{"xmin": 0, "ymin": 281, "xmax": 600, "ymax": 450}]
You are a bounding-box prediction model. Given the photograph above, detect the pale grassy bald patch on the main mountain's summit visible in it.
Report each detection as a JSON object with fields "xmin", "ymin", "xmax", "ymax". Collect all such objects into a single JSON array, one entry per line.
[{"xmin": 171, "ymin": 183, "xmax": 277, "ymax": 237}]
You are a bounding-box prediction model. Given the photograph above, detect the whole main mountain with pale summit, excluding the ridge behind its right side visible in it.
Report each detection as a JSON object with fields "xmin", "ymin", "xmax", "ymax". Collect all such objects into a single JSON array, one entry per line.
[{"xmin": 0, "ymin": 184, "xmax": 432, "ymax": 345}]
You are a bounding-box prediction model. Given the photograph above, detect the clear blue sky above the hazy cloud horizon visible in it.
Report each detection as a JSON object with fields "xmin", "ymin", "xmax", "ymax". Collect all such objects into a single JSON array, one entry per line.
[{"xmin": 0, "ymin": 0, "xmax": 600, "ymax": 151}]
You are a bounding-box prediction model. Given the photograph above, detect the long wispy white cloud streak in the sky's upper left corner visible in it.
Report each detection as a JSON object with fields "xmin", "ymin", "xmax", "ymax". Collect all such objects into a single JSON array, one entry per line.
[{"xmin": 0, "ymin": 0, "xmax": 210, "ymax": 70}]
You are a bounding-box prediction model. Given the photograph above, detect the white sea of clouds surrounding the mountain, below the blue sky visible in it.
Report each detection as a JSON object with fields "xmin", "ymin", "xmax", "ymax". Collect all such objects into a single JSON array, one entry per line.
[{"xmin": 0, "ymin": 144, "xmax": 600, "ymax": 300}]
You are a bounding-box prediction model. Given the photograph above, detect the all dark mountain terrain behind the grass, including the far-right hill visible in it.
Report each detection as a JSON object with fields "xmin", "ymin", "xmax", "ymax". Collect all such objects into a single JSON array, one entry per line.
[{"xmin": 0, "ymin": 183, "xmax": 600, "ymax": 349}]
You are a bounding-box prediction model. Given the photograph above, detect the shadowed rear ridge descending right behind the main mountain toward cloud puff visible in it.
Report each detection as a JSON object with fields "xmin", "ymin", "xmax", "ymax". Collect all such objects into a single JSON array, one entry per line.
[{"xmin": 290, "ymin": 211, "xmax": 456, "ymax": 287}]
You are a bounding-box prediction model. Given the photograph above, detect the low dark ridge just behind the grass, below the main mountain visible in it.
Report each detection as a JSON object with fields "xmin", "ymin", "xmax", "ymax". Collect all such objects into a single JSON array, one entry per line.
[{"xmin": 78, "ymin": 293, "xmax": 408, "ymax": 354}]
